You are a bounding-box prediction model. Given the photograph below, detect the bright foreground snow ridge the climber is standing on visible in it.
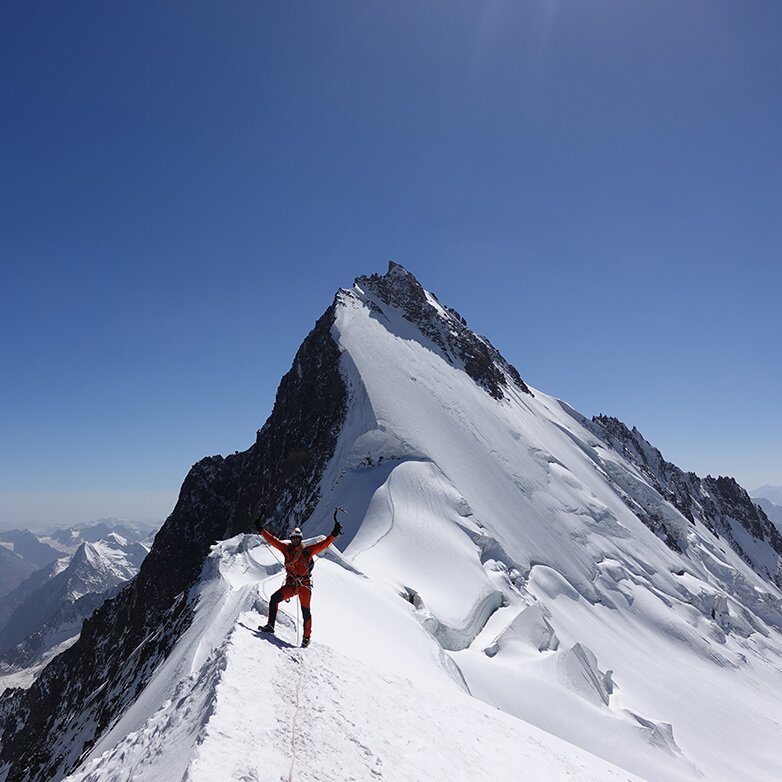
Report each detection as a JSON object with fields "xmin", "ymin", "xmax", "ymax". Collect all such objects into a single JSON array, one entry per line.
[{"xmin": 67, "ymin": 536, "xmax": 637, "ymax": 782}]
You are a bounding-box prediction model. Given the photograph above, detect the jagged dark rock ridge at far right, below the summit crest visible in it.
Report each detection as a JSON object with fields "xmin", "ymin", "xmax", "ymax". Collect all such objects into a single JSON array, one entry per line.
[{"xmin": 592, "ymin": 415, "xmax": 782, "ymax": 586}]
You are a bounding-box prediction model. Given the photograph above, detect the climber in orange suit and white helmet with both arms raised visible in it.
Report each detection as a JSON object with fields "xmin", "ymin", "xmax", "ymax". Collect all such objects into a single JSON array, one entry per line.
[{"xmin": 255, "ymin": 508, "xmax": 342, "ymax": 646}]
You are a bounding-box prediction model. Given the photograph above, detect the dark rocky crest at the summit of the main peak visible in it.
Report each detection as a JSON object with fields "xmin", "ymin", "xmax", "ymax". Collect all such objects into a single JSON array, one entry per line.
[{"xmin": 356, "ymin": 261, "xmax": 532, "ymax": 399}]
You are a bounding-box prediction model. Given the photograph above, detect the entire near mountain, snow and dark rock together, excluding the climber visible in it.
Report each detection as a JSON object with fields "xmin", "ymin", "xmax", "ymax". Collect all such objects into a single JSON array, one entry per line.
[{"xmin": 0, "ymin": 264, "xmax": 782, "ymax": 782}]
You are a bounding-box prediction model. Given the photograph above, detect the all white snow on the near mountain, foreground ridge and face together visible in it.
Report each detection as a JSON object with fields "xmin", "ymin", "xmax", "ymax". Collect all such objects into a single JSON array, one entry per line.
[{"xmin": 56, "ymin": 276, "xmax": 782, "ymax": 782}]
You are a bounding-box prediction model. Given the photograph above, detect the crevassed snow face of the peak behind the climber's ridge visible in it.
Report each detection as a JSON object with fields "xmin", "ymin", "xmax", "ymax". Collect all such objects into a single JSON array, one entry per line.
[{"xmin": 298, "ymin": 279, "xmax": 782, "ymax": 780}]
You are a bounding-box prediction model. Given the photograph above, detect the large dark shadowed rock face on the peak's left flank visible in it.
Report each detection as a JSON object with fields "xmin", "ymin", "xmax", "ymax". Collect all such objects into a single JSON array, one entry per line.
[{"xmin": 0, "ymin": 306, "xmax": 346, "ymax": 782}]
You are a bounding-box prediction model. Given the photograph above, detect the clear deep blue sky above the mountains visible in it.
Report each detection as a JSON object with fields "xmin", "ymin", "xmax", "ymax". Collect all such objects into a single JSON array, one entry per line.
[{"xmin": 0, "ymin": 0, "xmax": 782, "ymax": 526}]
